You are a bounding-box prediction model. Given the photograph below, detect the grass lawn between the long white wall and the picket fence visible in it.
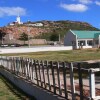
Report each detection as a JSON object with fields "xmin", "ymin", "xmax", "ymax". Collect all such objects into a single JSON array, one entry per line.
[{"xmin": 1, "ymin": 49, "xmax": 100, "ymax": 61}]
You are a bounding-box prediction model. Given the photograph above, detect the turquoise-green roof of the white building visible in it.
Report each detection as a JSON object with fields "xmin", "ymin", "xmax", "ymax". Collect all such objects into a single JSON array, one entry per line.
[{"xmin": 71, "ymin": 30, "xmax": 100, "ymax": 39}]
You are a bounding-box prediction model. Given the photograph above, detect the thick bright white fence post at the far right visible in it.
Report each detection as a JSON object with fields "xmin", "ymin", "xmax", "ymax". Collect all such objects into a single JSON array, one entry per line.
[{"xmin": 89, "ymin": 70, "xmax": 96, "ymax": 99}]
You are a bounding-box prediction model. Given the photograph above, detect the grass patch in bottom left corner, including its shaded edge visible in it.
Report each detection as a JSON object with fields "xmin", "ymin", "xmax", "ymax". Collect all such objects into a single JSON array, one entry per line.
[{"xmin": 0, "ymin": 75, "xmax": 34, "ymax": 100}]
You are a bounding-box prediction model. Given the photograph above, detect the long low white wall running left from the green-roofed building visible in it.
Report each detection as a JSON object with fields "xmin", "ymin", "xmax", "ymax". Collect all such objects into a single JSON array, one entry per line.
[{"xmin": 0, "ymin": 46, "xmax": 72, "ymax": 54}]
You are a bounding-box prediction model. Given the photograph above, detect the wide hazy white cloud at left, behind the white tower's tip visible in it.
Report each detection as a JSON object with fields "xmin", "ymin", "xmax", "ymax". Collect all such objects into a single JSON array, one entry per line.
[{"xmin": 0, "ymin": 7, "xmax": 26, "ymax": 17}]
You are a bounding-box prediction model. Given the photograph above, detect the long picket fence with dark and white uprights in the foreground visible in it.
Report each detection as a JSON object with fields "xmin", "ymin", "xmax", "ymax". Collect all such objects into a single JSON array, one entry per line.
[{"xmin": 0, "ymin": 56, "xmax": 100, "ymax": 100}]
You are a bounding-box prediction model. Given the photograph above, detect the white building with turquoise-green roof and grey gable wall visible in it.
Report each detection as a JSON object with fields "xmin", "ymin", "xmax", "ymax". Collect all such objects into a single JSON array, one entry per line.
[{"xmin": 64, "ymin": 30, "xmax": 100, "ymax": 49}]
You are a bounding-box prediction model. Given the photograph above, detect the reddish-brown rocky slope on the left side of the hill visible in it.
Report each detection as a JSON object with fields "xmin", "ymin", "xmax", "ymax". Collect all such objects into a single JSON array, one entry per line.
[{"xmin": 0, "ymin": 25, "xmax": 47, "ymax": 39}]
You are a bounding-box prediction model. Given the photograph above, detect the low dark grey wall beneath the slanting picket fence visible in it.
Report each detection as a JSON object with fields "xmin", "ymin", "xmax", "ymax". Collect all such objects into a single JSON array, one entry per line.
[{"xmin": 0, "ymin": 68, "xmax": 65, "ymax": 100}]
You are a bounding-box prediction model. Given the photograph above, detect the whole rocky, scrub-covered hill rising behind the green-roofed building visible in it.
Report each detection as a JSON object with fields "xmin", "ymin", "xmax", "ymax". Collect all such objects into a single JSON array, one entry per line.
[{"xmin": 0, "ymin": 20, "xmax": 99, "ymax": 40}]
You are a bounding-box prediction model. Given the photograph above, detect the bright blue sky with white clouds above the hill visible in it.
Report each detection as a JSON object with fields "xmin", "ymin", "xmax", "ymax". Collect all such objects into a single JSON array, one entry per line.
[{"xmin": 0, "ymin": 0, "xmax": 100, "ymax": 28}]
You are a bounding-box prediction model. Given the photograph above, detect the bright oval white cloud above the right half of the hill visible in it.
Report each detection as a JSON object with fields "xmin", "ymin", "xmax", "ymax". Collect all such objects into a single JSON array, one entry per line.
[{"xmin": 60, "ymin": 4, "xmax": 88, "ymax": 12}]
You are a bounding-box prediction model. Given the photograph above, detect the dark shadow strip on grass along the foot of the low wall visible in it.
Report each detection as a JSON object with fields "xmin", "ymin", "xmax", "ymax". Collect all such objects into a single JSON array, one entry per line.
[{"xmin": 0, "ymin": 74, "xmax": 36, "ymax": 100}]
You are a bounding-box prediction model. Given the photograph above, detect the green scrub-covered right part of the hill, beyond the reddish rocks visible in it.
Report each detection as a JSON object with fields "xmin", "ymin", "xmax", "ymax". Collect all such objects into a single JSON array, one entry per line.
[{"xmin": 35, "ymin": 20, "xmax": 99, "ymax": 40}]
